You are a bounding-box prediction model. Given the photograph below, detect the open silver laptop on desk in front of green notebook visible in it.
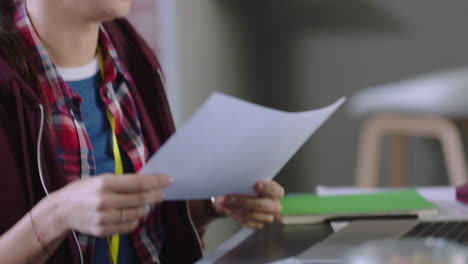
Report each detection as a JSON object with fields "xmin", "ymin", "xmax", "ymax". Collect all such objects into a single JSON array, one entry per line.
[{"xmin": 296, "ymin": 219, "xmax": 468, "ymax": 264}]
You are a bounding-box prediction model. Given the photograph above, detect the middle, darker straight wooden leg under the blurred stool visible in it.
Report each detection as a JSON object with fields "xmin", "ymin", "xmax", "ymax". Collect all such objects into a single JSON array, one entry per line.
[{"xmin": 390, "ymin": 134, "xmax": 408, "ymax": 187}]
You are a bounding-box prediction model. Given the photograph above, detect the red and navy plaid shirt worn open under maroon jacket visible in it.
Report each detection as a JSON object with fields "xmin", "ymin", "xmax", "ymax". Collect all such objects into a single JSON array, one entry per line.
[{"xmin": 15, "ymin": 3, "xmax": 164, "ymax": 263}]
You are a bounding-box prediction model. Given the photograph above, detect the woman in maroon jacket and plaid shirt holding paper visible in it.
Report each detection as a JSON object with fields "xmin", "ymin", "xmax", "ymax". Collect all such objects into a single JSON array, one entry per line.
[{"xmin": 0, "ymin": 0, "xmax": 284, "ymax": 263}]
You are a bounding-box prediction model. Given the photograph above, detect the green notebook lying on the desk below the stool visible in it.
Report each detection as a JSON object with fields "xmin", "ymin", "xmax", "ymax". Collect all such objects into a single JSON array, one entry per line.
[{"xmin": 281, "ymin": 190, "xmax": 437, "ymax": 224}]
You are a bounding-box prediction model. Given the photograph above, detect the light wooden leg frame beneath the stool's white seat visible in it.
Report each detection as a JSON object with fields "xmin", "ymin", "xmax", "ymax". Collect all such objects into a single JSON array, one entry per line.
[{"xmin": 356, "ymin": 113, "xmax": 467, "ymax": 187}]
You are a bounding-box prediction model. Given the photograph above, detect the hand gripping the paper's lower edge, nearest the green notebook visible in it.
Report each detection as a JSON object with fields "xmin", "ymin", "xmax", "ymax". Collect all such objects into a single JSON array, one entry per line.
[{"xmin": 215, "ymin": 181, "xmax": 284, "ymax": 229}]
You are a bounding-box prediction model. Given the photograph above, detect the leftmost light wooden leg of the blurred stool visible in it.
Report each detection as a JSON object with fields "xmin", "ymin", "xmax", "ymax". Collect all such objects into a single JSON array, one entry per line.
[{"xmin": 356, "ymin": 116, "xmax": 385, "ymax": 188}]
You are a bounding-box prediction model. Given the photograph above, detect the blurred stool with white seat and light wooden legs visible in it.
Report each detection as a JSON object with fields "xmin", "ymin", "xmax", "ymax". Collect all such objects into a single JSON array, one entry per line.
[{"xmin": 350, "ymin": 69, "xmax": 468, "ymax": 187}]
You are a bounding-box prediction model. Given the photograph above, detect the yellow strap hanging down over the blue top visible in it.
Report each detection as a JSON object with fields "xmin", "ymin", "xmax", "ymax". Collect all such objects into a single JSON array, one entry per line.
[{"xmin": 98, "ymin": 49, "xmax": 124, "ymax": 264}]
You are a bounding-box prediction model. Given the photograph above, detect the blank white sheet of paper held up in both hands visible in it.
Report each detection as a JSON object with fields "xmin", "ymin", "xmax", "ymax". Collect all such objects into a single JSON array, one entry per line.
[{"xmin": 140, "ymin": 93, "xmax": 345, "ymax": 200}]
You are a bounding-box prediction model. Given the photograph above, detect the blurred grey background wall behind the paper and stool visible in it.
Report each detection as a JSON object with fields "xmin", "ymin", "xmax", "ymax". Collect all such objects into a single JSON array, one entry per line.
[{"xmin": 130, "ymin": 0, "xmax": 468, "ymax": 256}]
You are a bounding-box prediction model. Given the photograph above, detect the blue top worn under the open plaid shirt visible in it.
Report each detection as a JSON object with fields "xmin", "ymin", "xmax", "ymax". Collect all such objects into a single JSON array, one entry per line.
[{"xmin": 67, "ymin": 72, "xmax": 140, "ymax": 264}]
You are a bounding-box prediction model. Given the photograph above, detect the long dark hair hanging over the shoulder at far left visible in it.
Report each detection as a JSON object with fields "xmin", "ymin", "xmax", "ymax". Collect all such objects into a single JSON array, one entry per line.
[{"xmin": 0, "ymin": 0, "xmax": 47, "ymax": 108}]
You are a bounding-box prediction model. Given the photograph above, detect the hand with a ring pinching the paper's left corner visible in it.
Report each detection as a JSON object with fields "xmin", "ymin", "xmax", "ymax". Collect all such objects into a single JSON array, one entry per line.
[{"xmin": 50, "ymin": 174, "xmax": 172, "ymax": 237}]
